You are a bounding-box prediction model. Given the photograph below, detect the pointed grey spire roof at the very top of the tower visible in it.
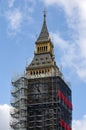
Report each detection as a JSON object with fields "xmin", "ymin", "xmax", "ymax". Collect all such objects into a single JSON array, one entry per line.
[{"xmin": 36, "ymin": 10, "xmax": 50, "ymax": 43}]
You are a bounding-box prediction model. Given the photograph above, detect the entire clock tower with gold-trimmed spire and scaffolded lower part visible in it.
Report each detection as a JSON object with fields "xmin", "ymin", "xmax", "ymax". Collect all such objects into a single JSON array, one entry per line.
[{"xmin": 10, "ymin": 11, "xmax": 72, "ymax": 130}]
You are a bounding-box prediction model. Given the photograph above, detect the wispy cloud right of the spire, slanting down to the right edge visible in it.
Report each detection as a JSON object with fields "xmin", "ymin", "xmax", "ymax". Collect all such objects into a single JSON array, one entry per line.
[{"xmin": 51, "ymin": 33, "xmax": 86, "ymax": 81}]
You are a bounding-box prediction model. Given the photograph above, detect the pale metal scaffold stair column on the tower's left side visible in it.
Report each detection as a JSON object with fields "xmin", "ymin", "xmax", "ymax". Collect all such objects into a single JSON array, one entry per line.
[{"xmin": 10, "ymin": 77, "xmax": 28, "ymax": 130}]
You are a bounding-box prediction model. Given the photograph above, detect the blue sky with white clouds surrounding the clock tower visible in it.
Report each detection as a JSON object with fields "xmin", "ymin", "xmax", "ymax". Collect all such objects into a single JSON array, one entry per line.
[{"xmin": 0, "ymin": 0, "xmax": 86, "ymax": 130}]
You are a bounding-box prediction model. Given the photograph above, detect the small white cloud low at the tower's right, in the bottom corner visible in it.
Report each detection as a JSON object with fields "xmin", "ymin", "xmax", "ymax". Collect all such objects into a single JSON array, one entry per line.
[{"xmin": 73, "ymin": 115, "xmax": 86, "ymax": 130}]
